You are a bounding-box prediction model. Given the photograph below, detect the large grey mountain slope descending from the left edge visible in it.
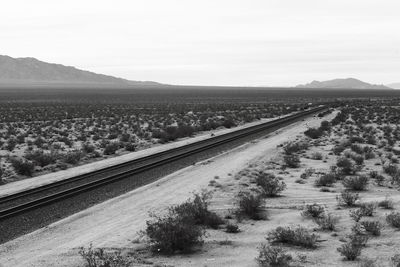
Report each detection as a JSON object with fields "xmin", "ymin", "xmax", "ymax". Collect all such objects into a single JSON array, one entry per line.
[{"xmin": 0, "ymin": 55, "xmax": 161, "ymax": 86}]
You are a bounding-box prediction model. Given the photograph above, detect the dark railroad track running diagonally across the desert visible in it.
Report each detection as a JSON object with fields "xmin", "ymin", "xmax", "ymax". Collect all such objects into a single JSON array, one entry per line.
[{"xmin": 0, "ymin": 106, "xmax": 327, "ymax": 223}]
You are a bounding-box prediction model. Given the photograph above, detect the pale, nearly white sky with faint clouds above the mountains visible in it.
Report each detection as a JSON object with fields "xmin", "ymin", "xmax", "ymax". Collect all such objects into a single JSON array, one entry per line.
[{"xmin": 0, "ymin": 0, "xmax": 400, "ymax": 86}]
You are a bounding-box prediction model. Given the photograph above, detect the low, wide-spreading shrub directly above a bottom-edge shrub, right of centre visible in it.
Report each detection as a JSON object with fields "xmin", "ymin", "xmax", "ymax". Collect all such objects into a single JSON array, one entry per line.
[{"xmin": 267, "ymin": 226, "xmax": 319, "ymax": 248}]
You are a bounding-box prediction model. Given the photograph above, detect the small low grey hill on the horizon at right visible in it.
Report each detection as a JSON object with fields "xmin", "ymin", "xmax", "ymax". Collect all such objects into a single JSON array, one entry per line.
[{"xmin": 296, "ymin": 78, "xmax": 392, "ymax": 89}]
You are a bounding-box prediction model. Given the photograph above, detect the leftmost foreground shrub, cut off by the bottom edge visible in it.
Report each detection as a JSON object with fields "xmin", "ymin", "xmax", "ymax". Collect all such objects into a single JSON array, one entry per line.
[{"xmin": 79, "ymin": 244, "xmax": 131, "ymax": 267}]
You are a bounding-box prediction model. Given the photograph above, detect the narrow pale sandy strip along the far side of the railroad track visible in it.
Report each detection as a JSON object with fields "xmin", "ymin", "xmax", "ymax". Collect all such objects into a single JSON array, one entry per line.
[{"xmin": 0, "ymin": 114, "xmax": 290, "ymax": 197}]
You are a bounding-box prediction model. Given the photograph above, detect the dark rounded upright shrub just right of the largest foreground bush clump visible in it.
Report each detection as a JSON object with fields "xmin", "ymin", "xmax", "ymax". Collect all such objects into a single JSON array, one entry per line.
[{"xmin": 236, "ymin": 191, "xmax": 265, "ymax": 220}]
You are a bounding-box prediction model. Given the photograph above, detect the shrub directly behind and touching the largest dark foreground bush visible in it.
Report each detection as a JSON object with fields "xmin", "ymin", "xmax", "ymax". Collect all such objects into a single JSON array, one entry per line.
[{"xmin": 172, "ymin": 192, "xmax": 224, "ymax": 229}]
